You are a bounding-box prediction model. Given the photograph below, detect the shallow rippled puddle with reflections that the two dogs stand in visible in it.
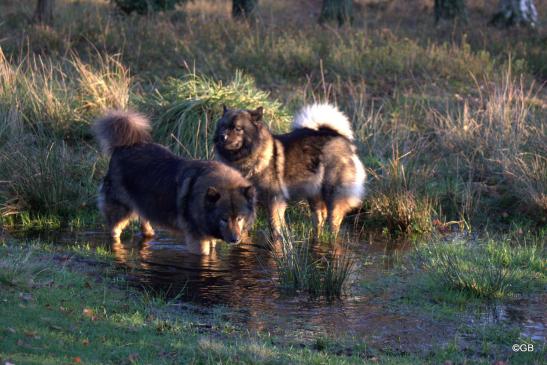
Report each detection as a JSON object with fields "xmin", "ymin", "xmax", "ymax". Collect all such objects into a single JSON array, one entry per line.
[{"xmin": 9, "ymin": 231, "xmax": 547, "ymax": 352}]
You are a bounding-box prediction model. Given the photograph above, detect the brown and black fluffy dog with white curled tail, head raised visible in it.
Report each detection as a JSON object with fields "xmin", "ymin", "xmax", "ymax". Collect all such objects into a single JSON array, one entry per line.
[{"xmin": 214, "ymin": 104, "xmax": 366, "ymax": 239}]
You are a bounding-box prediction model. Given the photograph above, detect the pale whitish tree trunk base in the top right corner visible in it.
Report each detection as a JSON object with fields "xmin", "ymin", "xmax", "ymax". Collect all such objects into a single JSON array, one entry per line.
[{"xmin": 490, "ymin": 0, "xmax": 538, "ymax": 28}]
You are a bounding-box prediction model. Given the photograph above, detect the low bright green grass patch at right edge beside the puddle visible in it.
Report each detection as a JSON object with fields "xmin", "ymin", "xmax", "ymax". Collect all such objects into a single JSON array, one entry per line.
[{"xmin": 416, "ymin": 236, "xmax": 547, "ymax": 299}]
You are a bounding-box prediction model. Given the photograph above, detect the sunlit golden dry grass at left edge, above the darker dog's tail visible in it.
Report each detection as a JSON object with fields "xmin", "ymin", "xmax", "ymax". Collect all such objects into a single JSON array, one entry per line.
[{"xmin": 0, "ymin": 49, "xmax": 131, "ymax": 139}]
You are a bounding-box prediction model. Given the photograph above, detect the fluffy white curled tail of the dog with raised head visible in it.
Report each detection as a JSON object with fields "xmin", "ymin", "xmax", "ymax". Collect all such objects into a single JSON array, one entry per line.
[{"xmin": 292, "ymin": 103, "xmax": 353, "ymax": 141}]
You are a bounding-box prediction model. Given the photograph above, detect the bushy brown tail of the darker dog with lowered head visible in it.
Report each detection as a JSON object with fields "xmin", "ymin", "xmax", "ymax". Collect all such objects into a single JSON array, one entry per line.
[{"xmin": 93, "ymin": 111, "xmax": 152, "ymax": 155}]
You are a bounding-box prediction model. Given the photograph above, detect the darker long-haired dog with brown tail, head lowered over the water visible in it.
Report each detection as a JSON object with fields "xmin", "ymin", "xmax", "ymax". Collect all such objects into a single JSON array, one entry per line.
[{"xmin": 93, "ymin": 111, "xmax": 256, "ymax": 253}]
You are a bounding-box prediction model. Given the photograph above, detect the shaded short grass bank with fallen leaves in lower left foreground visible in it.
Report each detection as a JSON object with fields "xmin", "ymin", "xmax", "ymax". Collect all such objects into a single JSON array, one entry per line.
[{"xmin": 0, "ymin": 241, "xmax": 470, "ymax": 364}]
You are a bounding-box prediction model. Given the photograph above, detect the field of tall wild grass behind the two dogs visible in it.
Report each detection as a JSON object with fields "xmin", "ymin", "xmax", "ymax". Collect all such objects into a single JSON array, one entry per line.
[{"xmin": 0, "ymin": 0, "xmax": 546, "ymax": 228}]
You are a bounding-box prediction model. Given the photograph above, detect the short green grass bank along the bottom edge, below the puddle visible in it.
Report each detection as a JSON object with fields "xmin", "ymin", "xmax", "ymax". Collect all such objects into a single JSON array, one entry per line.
[{"xmin": 0, "ymin": 236, "xmax": 545, "ymax": 364}]
